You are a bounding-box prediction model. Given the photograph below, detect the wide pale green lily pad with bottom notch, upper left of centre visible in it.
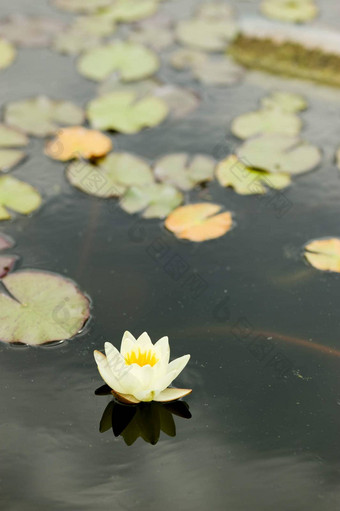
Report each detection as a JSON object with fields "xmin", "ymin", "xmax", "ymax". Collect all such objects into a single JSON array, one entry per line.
[{"xmin": 78, "ymin": 41, "xmax": 159, "ymax": 82}]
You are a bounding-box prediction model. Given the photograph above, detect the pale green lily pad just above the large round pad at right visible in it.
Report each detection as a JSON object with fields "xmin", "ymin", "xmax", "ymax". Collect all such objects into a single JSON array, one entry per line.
[{"xmin": 231, "ymin": 109, "xmax": 302, "ymax": 139}]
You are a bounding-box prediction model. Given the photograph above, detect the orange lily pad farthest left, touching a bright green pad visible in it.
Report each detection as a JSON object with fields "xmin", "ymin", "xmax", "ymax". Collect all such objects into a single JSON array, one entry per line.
[{"xmin": 45, "ymin": 126, "xmax": 112, "ymax": 161}]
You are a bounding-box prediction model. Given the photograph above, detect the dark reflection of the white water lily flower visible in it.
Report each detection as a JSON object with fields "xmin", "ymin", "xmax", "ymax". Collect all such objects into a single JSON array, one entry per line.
[{"xmin": 96, "ymin": 385, "xmax": 191, "ymax": 445}]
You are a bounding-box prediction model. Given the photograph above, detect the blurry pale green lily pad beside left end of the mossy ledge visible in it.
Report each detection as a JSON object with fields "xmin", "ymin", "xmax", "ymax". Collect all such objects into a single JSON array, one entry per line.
[{"xmin": 176, "ymin": 18, "xmax": 238, "ymax": 51}]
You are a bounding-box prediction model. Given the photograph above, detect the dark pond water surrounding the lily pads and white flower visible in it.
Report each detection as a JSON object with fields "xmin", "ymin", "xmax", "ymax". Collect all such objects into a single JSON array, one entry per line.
[{"xmin": 0, "ymin": 0, "xmax": 340, "ymax": 511}]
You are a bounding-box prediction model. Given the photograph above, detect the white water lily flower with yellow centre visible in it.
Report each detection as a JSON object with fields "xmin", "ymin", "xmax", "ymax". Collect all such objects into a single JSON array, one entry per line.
[{"xmin": 94, "ymin": 332, "xmax": 191, "ymax": 403}]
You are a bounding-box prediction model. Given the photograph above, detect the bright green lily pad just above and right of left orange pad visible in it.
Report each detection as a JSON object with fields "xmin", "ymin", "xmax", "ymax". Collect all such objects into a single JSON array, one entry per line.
[{"xmin": 87, "ymin": 92, "xmax": 169, "ymax": 134}]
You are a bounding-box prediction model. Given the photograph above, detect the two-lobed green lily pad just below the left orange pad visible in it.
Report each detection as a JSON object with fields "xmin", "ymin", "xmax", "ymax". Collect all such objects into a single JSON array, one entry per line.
[{"xmin": 66, "ymin": 153, "xmax": 154, "ymax": 198}]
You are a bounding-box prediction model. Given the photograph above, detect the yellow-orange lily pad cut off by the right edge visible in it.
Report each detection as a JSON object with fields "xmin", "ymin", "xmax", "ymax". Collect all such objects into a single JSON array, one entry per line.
[{"xmin": 305, "ymin": 238, "xmax": 340, "ymax": 273}]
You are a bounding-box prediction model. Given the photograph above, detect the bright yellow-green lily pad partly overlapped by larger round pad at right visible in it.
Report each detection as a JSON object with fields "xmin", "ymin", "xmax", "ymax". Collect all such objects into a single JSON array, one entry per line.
[{"xmin": 216, "ymin": 155, "xmax": 291, "ymax": 195}]
